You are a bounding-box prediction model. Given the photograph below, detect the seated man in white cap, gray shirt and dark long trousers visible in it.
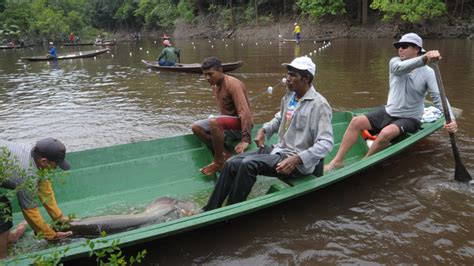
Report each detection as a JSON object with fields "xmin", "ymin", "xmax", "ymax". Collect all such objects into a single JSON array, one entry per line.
[{"xmin": 203, "ymin": 57, "xmax": 334, "ymax": 211}]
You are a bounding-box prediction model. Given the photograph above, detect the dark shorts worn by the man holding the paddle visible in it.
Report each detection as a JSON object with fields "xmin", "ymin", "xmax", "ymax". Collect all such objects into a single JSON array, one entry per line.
[{"xmin": 365, "ymin": 107, "xmax": 421, "ymax": 134}]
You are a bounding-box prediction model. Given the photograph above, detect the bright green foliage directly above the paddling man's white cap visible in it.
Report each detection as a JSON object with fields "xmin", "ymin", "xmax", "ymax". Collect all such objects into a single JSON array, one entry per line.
[{"xmin": 370, "ymin": 0, "xmax": 446, "ymax": 23}]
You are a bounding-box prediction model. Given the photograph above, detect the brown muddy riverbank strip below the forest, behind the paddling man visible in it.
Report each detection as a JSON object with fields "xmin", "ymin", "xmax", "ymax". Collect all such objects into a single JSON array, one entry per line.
[{"xmin": 172, "ymin": 20, "xmax": 474, "ymax": 40}]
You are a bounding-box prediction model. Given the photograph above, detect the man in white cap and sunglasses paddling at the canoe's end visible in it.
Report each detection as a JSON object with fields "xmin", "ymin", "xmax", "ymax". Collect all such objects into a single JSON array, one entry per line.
[{"xmin": 324, "ymin": 33, "xmax": 457, "ymax": 171}]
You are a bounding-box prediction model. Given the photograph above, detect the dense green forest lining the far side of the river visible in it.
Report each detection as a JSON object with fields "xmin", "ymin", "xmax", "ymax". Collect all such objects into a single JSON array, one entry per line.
[{"xmin": 0, "ymin": 0, "xmax": 474, "ymax": 42}]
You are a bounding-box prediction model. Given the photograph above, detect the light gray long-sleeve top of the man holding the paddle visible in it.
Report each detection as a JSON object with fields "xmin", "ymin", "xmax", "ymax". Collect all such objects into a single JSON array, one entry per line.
[{"xmin": 385, "ymin": 56, "xmax": 454, "ymax": 120}]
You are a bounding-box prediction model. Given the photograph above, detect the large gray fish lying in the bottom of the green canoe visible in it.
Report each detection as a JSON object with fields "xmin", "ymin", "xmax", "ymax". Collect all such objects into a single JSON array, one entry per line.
[{"xmin": 68, "ymin": 197, "xmax": 197, "ymax": 237}]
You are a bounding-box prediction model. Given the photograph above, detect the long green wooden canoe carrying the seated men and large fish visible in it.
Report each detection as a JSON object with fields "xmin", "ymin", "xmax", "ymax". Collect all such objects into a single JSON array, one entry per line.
[{"xmin": 0, "ymin": 106, "xmax": 444, "ymax": 264}]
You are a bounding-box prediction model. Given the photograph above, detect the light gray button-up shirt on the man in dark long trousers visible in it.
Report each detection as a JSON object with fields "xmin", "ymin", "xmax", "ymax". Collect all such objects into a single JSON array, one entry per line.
[{"xmin": 263, "ymin": 86, "xmax": 334, "ymax": 174}]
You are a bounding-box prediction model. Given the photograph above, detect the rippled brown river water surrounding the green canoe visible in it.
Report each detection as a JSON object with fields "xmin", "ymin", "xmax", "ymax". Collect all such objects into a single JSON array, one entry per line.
[{"xmin": 0, "ymin": 39, "xmax": 474, "ymax": 265}]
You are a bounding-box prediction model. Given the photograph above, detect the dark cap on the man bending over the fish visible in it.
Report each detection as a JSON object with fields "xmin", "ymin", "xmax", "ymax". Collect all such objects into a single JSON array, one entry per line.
[{"xmin": 35, "ymin": 138, "xmax": 71, "ymax": 170}]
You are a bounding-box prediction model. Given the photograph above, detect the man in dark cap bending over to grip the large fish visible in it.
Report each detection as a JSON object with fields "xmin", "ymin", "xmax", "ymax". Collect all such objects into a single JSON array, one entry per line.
[{"xmin": 0, "ymin": 138, "xmax": 72, "ymax": 259}]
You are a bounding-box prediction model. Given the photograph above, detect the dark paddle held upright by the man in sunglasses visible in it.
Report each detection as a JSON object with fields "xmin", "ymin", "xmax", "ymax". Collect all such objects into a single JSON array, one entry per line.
[{"xmin": 432, "ymin": 62, "xmax": 472, "ymax": 182}]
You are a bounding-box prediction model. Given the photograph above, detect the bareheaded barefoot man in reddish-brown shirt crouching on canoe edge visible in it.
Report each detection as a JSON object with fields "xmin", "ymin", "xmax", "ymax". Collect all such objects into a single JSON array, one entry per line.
[{"xmin": 191, "ymin": 57, "xmax": 253, "ymax": 175}]
